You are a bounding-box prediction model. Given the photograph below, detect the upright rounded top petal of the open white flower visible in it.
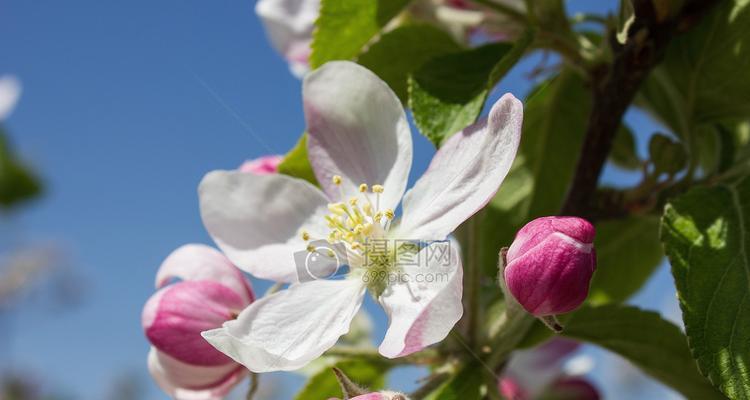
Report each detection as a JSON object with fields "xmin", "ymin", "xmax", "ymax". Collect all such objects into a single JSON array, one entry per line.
[{"xmin": 302, "ymin": 61, "xmax": 412, "ymax": 209}]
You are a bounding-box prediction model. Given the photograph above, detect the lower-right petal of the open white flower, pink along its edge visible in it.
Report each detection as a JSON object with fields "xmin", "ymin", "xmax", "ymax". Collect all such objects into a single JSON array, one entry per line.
[{"xmin": 378, "ymin": 241, "xmax": 463, "ymax": 358}]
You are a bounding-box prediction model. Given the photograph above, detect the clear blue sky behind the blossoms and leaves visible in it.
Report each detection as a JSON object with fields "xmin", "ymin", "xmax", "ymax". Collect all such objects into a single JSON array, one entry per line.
[{"xmin": 0, "ymin": 0, "xmax": 671, "ymax": 399}]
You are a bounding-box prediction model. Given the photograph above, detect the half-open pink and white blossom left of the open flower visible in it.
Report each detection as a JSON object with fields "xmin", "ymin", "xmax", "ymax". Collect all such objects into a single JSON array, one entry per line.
[{"xmin": 142, "ymin": 244, "xmax": 255, "ymax": 400}]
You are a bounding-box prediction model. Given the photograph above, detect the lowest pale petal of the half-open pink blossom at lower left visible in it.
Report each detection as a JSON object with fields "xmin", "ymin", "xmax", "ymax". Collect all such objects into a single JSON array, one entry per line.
[{"xmin": 148, "ymin": 347, "xmax": 247, "ymax": 400}]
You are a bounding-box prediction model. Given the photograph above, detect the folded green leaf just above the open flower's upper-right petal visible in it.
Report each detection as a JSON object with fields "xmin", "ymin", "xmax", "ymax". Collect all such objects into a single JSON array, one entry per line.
[{"xmin": 409, "ymin": 33, "xmax": 533, "ymax": 147}]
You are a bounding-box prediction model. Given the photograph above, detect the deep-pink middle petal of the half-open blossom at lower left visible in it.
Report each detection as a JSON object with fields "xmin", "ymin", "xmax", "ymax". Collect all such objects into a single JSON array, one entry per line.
[{"xmin": 142, "ymin": 281, "xmax": 246, "ymax": 366}]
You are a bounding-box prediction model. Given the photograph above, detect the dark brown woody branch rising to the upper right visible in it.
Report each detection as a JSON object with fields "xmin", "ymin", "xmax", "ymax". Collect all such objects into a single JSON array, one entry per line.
[{"xmin": 561, "ymin": 0, "xmax": 727, "ymax": 219}]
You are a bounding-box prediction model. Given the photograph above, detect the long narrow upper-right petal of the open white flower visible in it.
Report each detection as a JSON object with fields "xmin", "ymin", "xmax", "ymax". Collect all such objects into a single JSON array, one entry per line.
[{"xmin": 398, "ymin": 94, "xmax": 523, "ymax": 240}]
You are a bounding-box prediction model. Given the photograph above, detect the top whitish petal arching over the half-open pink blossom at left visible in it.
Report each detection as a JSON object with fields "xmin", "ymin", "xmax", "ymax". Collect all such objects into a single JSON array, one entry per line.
[{"xmin": 156, "ymin": 244, "xmax": 255, "ymax": 304}]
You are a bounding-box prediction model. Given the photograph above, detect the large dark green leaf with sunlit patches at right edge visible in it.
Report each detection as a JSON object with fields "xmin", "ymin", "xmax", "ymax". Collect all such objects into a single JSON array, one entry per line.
[{"xmin": 662, "ymin": 178, "xmax": 750, "ymax": 399}]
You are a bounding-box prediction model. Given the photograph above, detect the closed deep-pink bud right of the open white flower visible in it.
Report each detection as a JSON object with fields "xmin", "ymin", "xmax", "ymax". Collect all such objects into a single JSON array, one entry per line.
[{"xmin": 504, "ymin": 217, "xmax": 596, "ymax": 317}]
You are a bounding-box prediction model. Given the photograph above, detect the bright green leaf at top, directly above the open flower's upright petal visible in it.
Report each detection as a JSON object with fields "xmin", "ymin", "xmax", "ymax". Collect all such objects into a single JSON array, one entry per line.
[{"xmin": 310, "ymin": 0, "xmax": 410, "ymax": 68}]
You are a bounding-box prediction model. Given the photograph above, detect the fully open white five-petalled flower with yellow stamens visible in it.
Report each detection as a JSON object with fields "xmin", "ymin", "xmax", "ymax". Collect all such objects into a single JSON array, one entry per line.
[{"xmin": 199, "ymin": 61, "xmax": 523, "ymax": 372}]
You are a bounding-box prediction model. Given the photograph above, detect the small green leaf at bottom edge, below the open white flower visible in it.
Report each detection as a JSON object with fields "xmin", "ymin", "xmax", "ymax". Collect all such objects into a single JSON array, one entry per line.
[{"xmin": 294, "ymin": 360, "xmax": 390, "ymax": 400}]
